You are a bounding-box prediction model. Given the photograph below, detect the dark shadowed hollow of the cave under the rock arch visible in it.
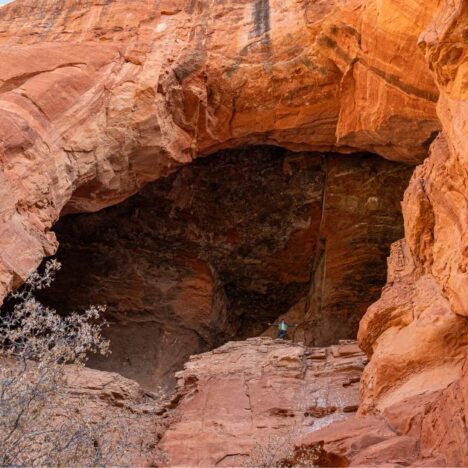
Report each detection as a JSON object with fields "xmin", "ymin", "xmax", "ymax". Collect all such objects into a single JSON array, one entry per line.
[{"xmin": 36, "ymin": 147, "xmax": 413, "ymax": 389}]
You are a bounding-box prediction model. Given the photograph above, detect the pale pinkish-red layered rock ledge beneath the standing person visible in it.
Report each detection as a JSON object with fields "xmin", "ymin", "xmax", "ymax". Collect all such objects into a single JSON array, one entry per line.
[{"xmin": 159, "ymin": 337, "xmax": 366, "ymax": 466}]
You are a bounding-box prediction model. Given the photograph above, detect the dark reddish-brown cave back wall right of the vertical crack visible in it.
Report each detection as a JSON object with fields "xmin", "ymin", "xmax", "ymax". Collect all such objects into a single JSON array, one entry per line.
[{"xmin": 304, "ymin": 156, "xmax": 412, "ymax": 346}]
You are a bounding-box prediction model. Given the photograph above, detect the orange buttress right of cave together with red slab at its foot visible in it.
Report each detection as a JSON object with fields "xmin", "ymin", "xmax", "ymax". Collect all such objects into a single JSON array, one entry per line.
[{"xmin": 296, "ymin": 136, "xmax": 468, "ymax": 460}]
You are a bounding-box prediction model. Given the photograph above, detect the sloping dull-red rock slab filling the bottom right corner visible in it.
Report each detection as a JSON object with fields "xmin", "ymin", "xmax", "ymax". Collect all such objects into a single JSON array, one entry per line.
[{"xmin": 291, "ymin": 360, "xmax": 468, "ymax": 467}]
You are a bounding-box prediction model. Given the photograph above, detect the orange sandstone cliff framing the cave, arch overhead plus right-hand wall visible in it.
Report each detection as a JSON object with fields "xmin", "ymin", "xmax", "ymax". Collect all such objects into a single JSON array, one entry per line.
[{"xmin": 0, "ymin": 0, "xmax": 468, "ymax": 465}]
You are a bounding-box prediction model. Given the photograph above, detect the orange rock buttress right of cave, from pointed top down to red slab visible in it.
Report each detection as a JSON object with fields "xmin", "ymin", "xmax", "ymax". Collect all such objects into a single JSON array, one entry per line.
[{"xmin": 358, "ymin": 137, "xmax": 468, "ymax": 413}]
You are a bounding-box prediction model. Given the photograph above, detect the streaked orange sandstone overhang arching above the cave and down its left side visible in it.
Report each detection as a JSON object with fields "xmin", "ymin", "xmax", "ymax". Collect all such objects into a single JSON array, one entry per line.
[{"xmin": 0, "ymin": 0, "xmax": 442, "ymax": 297}]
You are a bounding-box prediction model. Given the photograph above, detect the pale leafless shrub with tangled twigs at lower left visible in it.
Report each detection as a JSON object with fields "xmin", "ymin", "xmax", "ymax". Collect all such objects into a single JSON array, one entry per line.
[{"xmin": 0, "ymin": 261, "xmax": 159, "ymax": 466}]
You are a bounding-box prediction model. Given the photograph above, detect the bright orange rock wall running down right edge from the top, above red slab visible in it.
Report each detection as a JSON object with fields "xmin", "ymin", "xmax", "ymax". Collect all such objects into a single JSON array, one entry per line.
[{"xmin": 359, "ymin": 2, "xmax": 468, "ymax": 442}]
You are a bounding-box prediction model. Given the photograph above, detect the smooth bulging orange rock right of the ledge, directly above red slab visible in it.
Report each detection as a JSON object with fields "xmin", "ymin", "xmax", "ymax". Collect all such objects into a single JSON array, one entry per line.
[{"xmin": 359, "ymin": 234, "xmax": 468, "ymax": 413}]
